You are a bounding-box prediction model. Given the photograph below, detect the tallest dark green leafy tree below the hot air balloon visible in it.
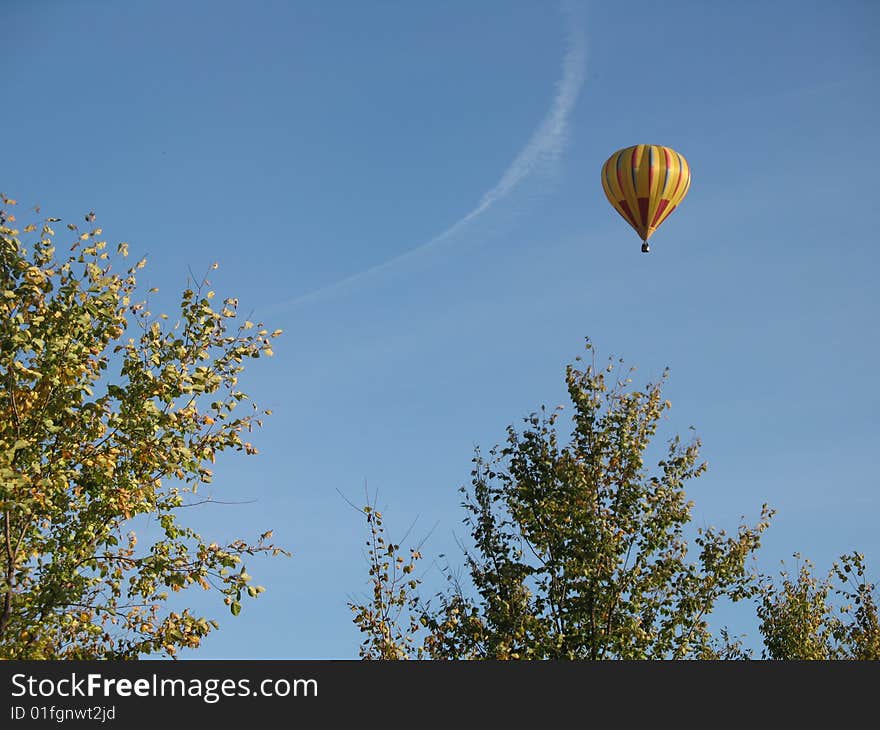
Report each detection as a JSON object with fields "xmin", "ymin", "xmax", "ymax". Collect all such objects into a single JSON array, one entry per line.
[{"xmin": 356, "ymin": 343, "xmax": 771, "ymax": 659}]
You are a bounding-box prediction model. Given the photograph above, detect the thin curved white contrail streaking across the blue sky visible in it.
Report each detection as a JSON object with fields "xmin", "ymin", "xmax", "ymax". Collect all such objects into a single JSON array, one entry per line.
[{"xmin": 269, "ymin": 3, "xmax": 587, "ymax": 312}]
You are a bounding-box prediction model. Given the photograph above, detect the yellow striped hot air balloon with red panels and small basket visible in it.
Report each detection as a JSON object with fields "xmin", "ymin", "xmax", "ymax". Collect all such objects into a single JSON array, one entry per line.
[{"xmin": 602, "ymin": 144, "xmax": 691, "ymax": 253}]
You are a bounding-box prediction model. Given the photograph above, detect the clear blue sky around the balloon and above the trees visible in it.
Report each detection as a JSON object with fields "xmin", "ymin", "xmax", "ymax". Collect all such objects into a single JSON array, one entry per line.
[{"xmin": 6, "ymin": 0, "xmax": 880, "ymax": 658}]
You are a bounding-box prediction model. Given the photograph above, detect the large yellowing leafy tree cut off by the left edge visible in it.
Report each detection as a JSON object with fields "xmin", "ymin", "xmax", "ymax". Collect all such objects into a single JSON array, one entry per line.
[{"xmin": 0, "ymin": 196, "xmax": 284, "ymax": 659}]
